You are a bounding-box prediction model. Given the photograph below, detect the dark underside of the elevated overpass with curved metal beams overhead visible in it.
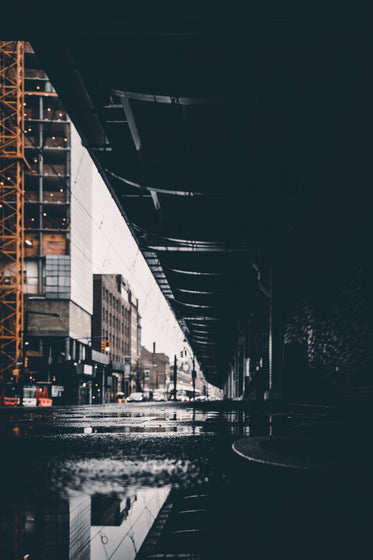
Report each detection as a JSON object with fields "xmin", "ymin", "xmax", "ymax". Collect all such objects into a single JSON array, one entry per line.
[{"xmin": 18, "ymin": 0, "xmax": 372, "ymax": 386}]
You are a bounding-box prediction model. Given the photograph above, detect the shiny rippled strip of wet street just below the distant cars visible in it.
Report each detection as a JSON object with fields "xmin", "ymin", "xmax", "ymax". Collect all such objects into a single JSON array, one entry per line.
[{"xmin": 0, "ymin": 407, "xmax": 284, "ymax": 438}]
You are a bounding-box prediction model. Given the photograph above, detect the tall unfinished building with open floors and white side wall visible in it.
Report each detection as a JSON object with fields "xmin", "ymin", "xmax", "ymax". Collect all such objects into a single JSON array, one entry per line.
[{"xmin": 24, "ymin": 43, "xmax": 93, "ymax": 403}]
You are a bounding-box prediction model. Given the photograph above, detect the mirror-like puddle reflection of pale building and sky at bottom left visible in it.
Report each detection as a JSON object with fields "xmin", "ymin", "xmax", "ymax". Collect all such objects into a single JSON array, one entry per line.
[{"xmin": 0, "ymin": 487, "xmax": 170, "ymax": 560}]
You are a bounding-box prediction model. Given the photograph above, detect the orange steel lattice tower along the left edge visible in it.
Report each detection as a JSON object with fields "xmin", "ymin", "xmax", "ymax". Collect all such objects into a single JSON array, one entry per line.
[{"xmin": 0, "ymin": 41, "xmax": 25, "ymax": 381}]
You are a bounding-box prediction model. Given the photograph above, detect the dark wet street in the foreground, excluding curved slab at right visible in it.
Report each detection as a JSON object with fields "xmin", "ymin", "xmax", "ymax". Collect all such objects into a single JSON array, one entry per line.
[{"xmin": 0, "ymin": 403, "xmax": 369, "ymax": 560}]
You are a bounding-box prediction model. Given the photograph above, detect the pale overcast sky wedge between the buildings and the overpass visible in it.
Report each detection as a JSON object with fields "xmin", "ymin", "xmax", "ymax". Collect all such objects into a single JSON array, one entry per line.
[{"xmin": 92, "ymin": 164, "xmax": 188, "ymax": 359}]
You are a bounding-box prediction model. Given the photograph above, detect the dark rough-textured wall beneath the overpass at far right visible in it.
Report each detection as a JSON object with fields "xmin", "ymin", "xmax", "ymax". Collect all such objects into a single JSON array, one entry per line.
[{"xmin": 284, "ymin": 259, "xmax": 373, "ymax": 394}]
